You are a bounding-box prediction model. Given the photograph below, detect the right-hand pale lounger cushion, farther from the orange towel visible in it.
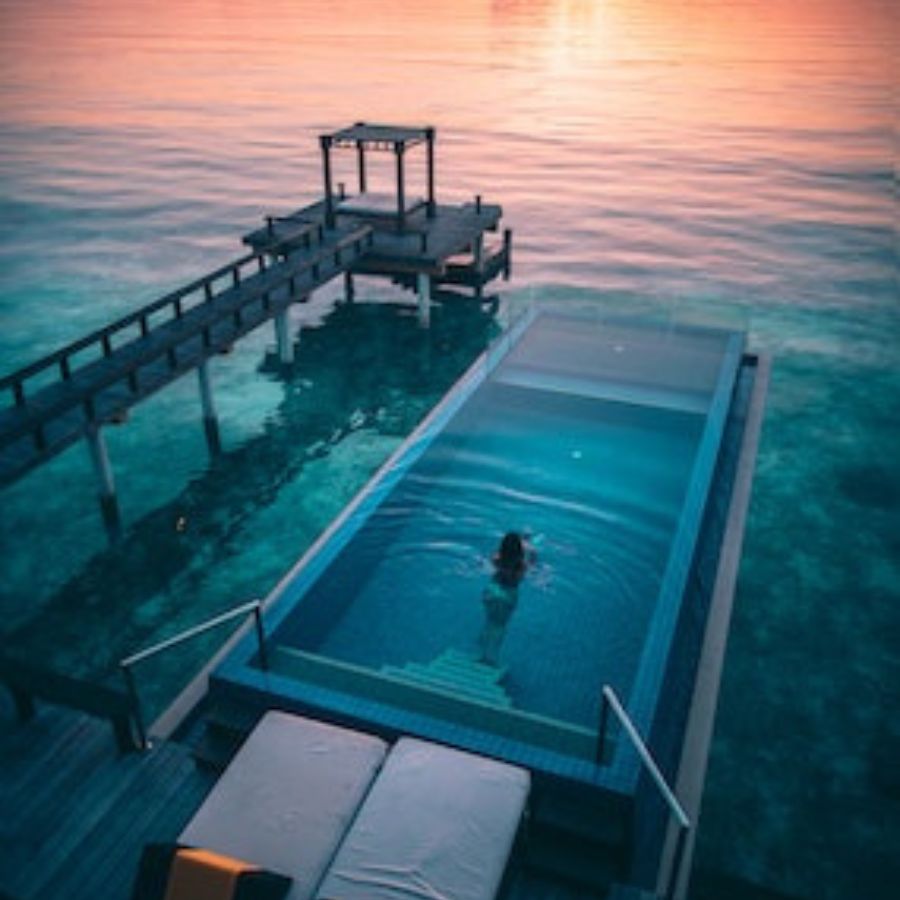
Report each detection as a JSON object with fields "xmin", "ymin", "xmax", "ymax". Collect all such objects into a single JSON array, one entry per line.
[{"xmin": 316, "ymin": 738, "xmax": 530, "ymax": 900}]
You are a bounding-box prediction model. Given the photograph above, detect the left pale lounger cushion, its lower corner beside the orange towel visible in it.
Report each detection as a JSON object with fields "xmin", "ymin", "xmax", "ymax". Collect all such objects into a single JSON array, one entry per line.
[{"xmin": 179, "ymin": 712, "xmax": 386, "ymax": 900}]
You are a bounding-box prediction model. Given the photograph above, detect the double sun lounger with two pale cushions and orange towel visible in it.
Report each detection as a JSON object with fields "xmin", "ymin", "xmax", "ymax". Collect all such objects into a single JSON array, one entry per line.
[{"xmin": 141, "ymin": 712, "xmax": 530, "ymax": 900}]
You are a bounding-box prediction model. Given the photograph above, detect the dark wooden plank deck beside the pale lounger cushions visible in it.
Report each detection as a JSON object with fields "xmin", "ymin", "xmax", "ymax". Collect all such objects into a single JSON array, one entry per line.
[{"xmin": 0, "ymin": 692, "xmax": 604, "ymax": 900}]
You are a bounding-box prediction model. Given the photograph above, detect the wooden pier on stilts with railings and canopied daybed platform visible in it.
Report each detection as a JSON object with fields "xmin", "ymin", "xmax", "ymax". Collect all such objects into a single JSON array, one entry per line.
[{"xmin": 0, "ymin": 123, "xmax": 511, "ymax": 536}]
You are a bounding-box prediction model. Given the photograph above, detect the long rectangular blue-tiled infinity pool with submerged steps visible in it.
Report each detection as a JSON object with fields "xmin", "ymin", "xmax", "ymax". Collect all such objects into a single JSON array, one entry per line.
[{"xmin": 214, "ymin": 314, "xmax": 742, "ymax": 788}]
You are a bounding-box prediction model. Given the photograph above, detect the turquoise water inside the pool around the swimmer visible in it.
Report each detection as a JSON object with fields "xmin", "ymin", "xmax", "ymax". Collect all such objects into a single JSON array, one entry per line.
[{"xmin": 277, "ymin": 317, "xmax": 722, "ymax": 727}]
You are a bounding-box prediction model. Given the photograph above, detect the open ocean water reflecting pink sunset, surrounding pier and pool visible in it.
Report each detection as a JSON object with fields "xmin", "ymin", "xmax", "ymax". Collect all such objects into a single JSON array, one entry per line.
[{"xmin": 0, "ymin": 0, "xmax": 900, "ymax": 900}]
